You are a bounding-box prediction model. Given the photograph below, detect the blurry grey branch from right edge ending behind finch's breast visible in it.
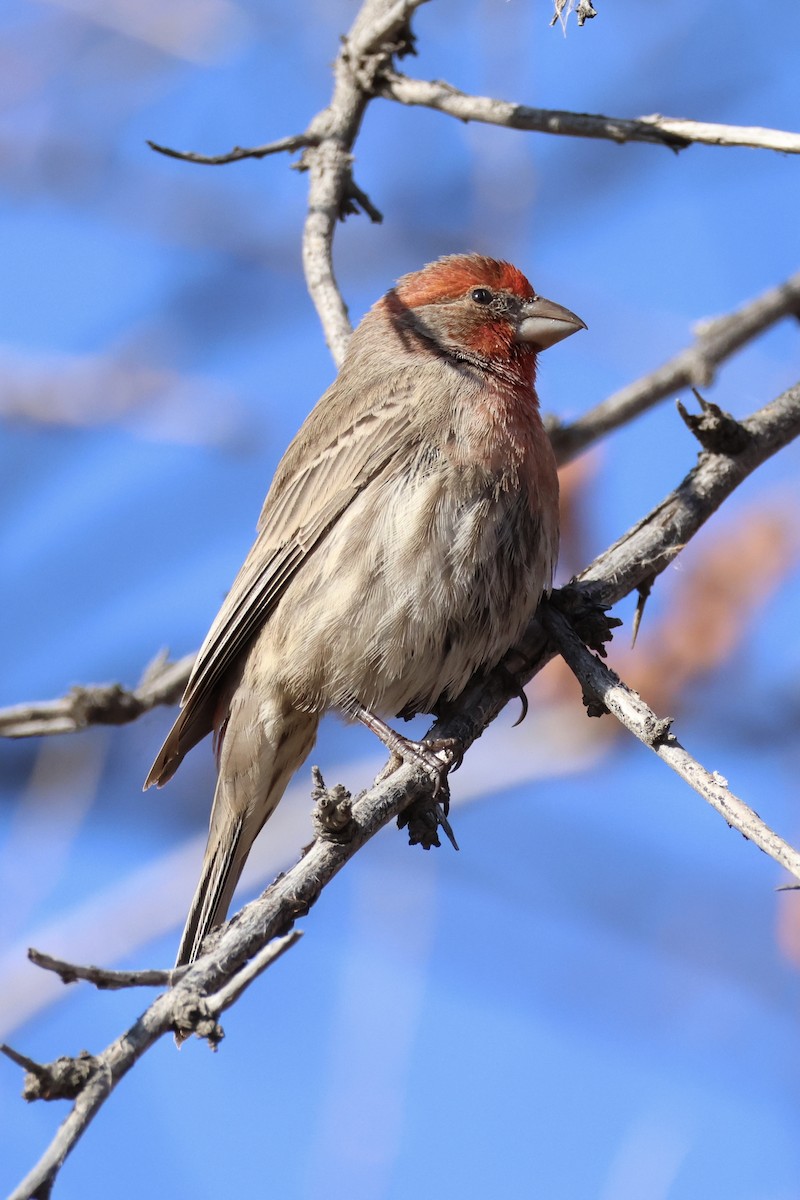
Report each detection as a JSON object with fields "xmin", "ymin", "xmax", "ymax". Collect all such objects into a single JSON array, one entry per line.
[{"xmin": 548, "ymin": 271, "xmax": 800, "ymax": 464}]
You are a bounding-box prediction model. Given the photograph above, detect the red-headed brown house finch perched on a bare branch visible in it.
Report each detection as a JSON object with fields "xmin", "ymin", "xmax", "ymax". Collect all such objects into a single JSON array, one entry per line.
[{"xmin": 145, "ymin": 254, "xmax": 585, "ymax": 965}]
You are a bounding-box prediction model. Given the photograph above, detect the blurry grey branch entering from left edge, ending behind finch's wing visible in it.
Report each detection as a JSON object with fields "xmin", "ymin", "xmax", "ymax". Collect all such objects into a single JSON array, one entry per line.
[{"xmin": 0, "ymin": 654, "xmax": 194, "ymax": 738}]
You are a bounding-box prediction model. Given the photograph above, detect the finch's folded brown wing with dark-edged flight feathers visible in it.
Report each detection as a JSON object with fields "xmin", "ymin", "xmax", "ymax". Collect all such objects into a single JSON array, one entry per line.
[{"xmin": 145, "ymin": 378, "xmax": 415, "ymax": 787}]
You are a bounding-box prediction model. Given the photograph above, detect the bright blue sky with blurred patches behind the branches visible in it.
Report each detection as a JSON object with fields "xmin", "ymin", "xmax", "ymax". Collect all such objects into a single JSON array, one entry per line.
[{"xmin": 0, "ymin": 0, "xmax": 800, "ymax": 1200}]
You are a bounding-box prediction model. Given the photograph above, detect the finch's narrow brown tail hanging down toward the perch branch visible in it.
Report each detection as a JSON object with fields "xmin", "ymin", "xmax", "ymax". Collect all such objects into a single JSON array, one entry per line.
[{"xmin": 175, "ymin": 686, "xmax": 319, "ymax": 966}]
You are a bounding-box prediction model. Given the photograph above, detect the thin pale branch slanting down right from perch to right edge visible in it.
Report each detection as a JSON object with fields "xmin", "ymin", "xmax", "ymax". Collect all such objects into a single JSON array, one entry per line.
[{"xmin": 540, "ymin": 605, "xmax": 800, "ymax": 880}]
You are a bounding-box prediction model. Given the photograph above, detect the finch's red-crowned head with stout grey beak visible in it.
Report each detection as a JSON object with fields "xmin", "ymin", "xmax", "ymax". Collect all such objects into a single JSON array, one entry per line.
[{"xmin": 381, "ymin": 254, "xmax": 587, "ymax": 376}]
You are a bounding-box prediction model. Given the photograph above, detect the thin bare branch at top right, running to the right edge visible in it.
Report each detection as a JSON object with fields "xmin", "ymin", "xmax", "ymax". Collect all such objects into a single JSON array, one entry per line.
[{"xmin": 380, "ymin": 71, "xmax": 800, "ymax": 154}]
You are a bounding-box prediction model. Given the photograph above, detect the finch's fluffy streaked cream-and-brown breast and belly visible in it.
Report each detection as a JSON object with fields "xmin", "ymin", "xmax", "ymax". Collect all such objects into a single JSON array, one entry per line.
[{"xmin": 261, "ymin": 427, "xmax": 558, "ymax": 714}]
